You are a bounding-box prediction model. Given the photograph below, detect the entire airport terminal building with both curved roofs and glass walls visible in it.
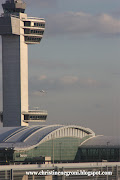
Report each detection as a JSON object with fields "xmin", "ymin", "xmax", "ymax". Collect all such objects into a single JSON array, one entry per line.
[{"xmin": 0, "ymin": 125, "xmax": 120, "ymax": 164}]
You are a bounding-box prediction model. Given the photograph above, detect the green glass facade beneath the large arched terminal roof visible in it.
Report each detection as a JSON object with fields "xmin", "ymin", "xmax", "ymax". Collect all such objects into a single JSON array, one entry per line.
[{"xmin": 14, "ymin": 137, "xmax": 91, "ymax": 162}]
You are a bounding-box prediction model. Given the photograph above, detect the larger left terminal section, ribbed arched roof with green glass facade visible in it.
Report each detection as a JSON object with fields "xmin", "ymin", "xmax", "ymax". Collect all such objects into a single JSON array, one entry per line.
[{"xmin": 0, "ymin": 125, "xmax": 95, "ymax": 163}]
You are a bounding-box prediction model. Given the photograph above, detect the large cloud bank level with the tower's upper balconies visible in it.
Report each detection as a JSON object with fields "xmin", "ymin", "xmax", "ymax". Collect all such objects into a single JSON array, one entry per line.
[{"xmin": 46, "ymin": 12, "xmax": 120, "ymax": 35}]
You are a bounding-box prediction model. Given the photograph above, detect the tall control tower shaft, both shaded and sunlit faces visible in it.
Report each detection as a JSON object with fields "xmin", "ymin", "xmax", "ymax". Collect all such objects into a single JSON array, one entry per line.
[{"xmin": 2, "ymin": 35, "xmax": 28, "ymax": 126}]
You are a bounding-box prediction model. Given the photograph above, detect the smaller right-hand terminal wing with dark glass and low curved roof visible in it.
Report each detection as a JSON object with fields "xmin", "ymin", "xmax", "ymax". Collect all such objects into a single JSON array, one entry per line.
[{"xmin": 76, "ymin": 136, "xmax": 120, "ymax": 162}]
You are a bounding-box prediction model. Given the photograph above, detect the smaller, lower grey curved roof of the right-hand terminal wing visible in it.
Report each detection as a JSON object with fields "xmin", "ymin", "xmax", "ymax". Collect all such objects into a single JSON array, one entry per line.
[{"xmin": 79, "ymin": 136, "xmax": 120, "ymax": 148}]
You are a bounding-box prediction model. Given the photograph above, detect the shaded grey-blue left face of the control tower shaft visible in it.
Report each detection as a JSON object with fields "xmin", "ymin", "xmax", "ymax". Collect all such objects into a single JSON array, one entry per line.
[{"xmin": 2, "ymin": 35, "xmax": 21, "ymax": 126}]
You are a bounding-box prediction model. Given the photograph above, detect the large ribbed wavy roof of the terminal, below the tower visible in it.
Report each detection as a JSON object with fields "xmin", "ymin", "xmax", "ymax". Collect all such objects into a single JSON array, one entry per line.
[{"xmin": 0, "ymin": 125, "xmax": 95, "ymax": 150}]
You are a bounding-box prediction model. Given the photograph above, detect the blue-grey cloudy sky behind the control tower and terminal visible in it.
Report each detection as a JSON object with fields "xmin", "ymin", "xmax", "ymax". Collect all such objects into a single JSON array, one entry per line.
[{"xmin": 0, "ymin": 0, "xmax": 120, "ymax": 136}]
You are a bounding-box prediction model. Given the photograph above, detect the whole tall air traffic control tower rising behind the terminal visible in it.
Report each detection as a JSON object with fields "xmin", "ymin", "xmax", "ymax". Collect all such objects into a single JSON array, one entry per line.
[{"xmin": 0, "ymin": 0, "xmax": 47, "ymax": 127}]
